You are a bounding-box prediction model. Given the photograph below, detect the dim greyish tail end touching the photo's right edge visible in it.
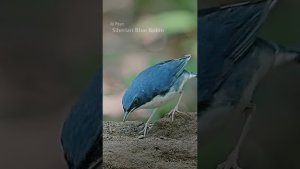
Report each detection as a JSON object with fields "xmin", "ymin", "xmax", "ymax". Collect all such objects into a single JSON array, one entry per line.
[{"xmin": 274, "ymin": 45, "xmax": 300, "ymax": 67}]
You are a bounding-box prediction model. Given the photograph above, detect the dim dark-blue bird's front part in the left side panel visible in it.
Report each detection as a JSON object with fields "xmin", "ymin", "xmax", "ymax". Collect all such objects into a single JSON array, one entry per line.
[{"xmin": 61, "ymin": 70, "xmax": 102, "ymax": 169}]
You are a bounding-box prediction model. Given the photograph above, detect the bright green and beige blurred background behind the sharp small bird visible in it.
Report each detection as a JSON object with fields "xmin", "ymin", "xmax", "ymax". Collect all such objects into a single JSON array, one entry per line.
[{"xmin": 103, "ymin": 0, "xmax": 197, "ymax": 121}]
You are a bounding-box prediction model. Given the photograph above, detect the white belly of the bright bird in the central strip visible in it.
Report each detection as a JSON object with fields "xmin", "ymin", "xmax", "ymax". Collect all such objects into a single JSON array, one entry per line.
[{"xmin": 138, "ymin": 92, "xmax": 178, "ymax": 109}]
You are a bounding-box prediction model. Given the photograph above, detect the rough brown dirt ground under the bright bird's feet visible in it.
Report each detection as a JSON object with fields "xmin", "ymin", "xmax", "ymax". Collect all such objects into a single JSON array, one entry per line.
[{"xmin": 103, "ymin": 112, "xmax": 197, "ymax": 169}]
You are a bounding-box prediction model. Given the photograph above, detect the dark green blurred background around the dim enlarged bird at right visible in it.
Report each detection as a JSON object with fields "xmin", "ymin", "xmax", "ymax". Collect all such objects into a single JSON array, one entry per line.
[{"xmin": 198, "ymin": 0, "xmax": 300, "ymax": 169}]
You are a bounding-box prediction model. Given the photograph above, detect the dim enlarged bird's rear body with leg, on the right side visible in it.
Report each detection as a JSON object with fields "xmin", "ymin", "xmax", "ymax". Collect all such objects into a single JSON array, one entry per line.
[{"xmin": 198, "ymin": 0, "xmax": 300, "ymax": 169}]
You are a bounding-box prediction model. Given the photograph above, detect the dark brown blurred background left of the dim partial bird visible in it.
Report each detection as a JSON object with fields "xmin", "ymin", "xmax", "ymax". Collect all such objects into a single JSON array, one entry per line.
[{"xmin": 0, "ymin": 0, "xmax": 101, "ymax": 169}]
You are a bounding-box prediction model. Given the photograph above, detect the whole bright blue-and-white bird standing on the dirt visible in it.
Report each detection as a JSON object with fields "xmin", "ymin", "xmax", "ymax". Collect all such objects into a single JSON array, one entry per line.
[{"xmin": 122, "ymin": 55, "xmax": 196, "ymax": 137}]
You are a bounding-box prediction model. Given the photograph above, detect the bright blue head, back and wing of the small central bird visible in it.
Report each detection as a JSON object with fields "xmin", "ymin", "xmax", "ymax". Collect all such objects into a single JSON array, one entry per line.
[{"xmin": 122, "ymin": 57, "xmax": 189, "ymax": 110}]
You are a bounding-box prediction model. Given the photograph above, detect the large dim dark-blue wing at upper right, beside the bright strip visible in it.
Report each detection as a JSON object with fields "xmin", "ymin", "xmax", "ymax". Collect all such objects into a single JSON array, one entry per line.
[{"xmin": 198, "ymin": 0, "xmax": 275, "ymax": 104}]
